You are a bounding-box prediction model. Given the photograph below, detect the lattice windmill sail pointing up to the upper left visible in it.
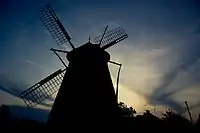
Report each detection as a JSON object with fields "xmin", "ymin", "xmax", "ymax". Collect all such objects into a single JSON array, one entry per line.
[{"xmin": 40, "ymin": 5, "xmax": 75, "ymax": 49}]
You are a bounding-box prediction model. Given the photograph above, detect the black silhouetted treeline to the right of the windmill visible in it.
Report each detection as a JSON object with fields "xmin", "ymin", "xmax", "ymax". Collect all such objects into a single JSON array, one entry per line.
[{"xmin": 119, "ymin": 103, "xmax": 200, "ymax": 133}]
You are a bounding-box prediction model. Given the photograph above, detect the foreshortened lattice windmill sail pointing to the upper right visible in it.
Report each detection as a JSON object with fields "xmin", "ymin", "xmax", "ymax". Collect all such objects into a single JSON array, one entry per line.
[{"xmin": 94, "ymin": 27, "xmax": 128, "ymax": 49}]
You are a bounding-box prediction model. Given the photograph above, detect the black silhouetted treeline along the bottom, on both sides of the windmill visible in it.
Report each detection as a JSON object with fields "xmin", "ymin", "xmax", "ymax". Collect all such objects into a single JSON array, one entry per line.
[{"xmin": 0, "ymin": 103, "xmax": 200, "ymax": 133}]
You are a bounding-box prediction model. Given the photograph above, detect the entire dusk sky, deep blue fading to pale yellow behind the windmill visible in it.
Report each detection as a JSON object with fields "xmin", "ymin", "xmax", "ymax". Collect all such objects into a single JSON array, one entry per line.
[{"xmin": 0, "ymin": 0, "xmax": 200, "ymax": 118}]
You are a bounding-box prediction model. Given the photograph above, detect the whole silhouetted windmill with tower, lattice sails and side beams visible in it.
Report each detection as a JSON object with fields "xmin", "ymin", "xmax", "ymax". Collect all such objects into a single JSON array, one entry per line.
[{"xmin": 20, "ymin": 5, "xmax": 128, "ymax": 128}]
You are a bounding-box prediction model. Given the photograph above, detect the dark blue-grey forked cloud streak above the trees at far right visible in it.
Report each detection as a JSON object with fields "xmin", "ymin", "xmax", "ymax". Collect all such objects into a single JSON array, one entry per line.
[{"xmin": 150, "ymin": 54, "xmax": 200, "ymax": 113}]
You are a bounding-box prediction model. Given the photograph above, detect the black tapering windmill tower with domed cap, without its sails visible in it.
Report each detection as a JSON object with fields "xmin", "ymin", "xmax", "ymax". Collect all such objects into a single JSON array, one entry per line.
[{"xmin": 48, "ymin": 43, "xmax": 118, "ymax": 128}]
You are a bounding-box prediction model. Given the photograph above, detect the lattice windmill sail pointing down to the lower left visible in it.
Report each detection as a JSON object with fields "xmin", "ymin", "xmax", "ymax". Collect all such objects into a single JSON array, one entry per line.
[{"xmin": 20, "ymin": 69, "xmax": 66, "ymax": 107}]
